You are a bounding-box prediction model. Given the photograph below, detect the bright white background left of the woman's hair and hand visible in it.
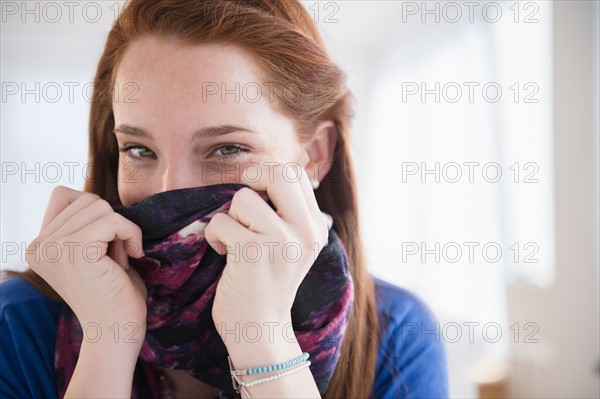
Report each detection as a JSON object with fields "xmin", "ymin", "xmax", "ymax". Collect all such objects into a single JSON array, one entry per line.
[{"xmin": 0, "ymin": 1, "xmax": 118, "ymax": 268}]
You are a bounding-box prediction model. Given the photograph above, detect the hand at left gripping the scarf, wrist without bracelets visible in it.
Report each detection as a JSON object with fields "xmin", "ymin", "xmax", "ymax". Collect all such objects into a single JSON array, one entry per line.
[{"xmin": 25, "ymin": 186, "xmax": 147, "ymax": 334}]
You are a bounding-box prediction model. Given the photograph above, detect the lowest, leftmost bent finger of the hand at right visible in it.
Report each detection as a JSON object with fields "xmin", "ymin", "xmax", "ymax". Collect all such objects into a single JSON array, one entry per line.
[{"xmin": 204, "ymin": 212, "xmax": 254, "ymax": 255}]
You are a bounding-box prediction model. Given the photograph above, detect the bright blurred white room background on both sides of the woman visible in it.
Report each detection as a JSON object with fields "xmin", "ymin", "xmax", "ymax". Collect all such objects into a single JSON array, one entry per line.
[{"xmin": 0, "ymin": 0, "xmax": 600, "ymax": 398}]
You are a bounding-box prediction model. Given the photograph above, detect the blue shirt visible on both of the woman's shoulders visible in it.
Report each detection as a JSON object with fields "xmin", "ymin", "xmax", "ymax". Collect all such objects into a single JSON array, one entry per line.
[{"xmin": 0, "ymin": 277, "xmax": 448, "ymax": 399}]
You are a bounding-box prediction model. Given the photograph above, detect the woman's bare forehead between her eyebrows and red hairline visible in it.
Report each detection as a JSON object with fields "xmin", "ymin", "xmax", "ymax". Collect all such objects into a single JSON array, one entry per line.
[{"xmin": 113, "ymin": 37, "xmax": 283, "ymax": 135}]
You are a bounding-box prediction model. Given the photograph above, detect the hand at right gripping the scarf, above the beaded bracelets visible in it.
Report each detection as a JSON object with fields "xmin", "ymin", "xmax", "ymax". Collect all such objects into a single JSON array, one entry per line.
[{"xmin": 205, "ymin": 164, "xmax": 329, "ymax": 349}]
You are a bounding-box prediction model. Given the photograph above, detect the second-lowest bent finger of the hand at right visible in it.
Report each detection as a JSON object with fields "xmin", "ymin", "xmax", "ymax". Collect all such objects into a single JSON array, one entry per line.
[{"xmin": 227, "ymin": 187, "xmax": 281, "ymax": 233}]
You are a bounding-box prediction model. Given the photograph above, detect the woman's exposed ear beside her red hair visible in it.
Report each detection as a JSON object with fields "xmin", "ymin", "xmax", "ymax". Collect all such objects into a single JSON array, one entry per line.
[{"xmin": 304, "ymin": 120, "xmax": 338, "ymax": 182}]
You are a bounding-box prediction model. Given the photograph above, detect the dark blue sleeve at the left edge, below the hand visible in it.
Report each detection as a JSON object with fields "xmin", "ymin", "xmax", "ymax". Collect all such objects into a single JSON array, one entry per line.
[{"xmin": 0, "ymin": 278, "xmax": 58, "ymax": 399}]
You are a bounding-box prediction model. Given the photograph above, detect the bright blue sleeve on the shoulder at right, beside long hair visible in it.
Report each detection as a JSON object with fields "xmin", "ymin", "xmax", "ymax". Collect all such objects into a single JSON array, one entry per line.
[{"xmin": 372, "ymin": 280, "xmax": 448, "ymax": 399}]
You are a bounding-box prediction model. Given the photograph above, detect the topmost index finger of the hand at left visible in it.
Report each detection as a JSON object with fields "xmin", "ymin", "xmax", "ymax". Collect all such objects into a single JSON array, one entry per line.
[{"xmin": 40, "ymin": 186, "xmax": 100, "ymax": 237}]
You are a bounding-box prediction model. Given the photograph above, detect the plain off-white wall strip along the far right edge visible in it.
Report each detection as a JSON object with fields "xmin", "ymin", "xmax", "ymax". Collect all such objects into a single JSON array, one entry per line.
[{"xmin": 508, "ymin": 1, "xmax": 600, "ymax": 398}]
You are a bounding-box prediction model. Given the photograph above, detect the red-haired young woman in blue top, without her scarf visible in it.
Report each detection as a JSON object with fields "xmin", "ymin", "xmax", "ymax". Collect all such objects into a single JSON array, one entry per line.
[{"xmin": 0, "ymin": 0, "xmax": 447, "ymax": 398}]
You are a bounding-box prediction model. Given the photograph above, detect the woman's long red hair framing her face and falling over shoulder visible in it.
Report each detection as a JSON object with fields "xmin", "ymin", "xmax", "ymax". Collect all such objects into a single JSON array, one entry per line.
[{"xmin": 11, "ymin": 0, "xmax": 378, "ymax": 398}]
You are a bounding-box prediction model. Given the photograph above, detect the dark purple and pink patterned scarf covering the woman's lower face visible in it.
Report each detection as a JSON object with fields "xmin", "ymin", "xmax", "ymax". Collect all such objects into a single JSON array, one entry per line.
[{"xmin": 55, "ymin": 184, "xmax": 354, "ymax": 398}]
